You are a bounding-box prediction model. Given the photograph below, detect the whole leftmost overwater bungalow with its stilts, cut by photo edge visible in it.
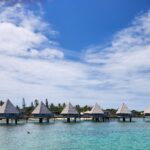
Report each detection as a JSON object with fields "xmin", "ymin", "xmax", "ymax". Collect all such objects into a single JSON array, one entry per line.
[{"xmin": 0, "ymin": 100, "xmax": 19, "ymax": 124}]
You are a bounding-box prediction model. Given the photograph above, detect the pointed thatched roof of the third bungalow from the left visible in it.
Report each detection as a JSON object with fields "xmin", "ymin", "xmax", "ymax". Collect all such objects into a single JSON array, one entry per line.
[{"xmin": 61, "ymin": 103, "xmax": 79, "ymax": 115}]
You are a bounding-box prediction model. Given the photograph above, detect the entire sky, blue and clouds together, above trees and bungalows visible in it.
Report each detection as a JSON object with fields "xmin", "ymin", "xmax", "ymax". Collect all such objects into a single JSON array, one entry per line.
[{"xmin": 0, "ymin": 0, "xmax": 150, "ymax": 110}]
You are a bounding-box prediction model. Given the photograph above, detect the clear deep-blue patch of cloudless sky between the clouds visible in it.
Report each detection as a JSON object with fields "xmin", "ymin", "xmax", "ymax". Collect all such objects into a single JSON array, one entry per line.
[{"xmin": 42, "ymin": 0, "xmax": 150, "ymax": 51}]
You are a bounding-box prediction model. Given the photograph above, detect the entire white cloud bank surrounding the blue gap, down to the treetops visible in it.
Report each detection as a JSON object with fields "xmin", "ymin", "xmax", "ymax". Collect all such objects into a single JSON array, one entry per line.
[{"xmin": 0, "ymin": 3, "xmax": 150, "ymax": 108}]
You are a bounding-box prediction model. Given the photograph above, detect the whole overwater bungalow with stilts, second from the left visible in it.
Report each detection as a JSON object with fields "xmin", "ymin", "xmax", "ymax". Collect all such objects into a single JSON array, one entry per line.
[{"xmin": 32, "ymin": 102, "xmax": 54, "ymax": 123}]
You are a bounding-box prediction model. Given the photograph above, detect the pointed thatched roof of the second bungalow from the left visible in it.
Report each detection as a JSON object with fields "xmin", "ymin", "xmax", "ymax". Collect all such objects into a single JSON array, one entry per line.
[{"xmin": 32, "ymin": 102, "xmax": 52, "ymax": 115}]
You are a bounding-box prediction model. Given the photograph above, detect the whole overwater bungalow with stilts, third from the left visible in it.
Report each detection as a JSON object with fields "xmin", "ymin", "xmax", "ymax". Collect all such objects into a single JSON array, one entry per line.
[{"xmin": 61, "ymin": 103, "xmax": 80, "ymax": 122}]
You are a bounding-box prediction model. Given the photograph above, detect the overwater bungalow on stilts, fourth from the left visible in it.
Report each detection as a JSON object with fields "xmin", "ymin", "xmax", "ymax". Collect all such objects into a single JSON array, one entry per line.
[{"xmin": 90, "ymin": 103, "xmax": 105, "ymax": 122}]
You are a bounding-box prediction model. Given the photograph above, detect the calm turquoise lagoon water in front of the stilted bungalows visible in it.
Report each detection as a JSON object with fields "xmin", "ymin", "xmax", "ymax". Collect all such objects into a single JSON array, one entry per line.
[{"xmin": 0, "ymin": 119, "xmax": 150, "ymax": 150}]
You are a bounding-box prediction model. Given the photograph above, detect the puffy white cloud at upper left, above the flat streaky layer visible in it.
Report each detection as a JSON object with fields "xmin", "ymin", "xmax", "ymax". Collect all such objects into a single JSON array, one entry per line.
[{"xmin": 0, "ymin": 4, "xmax": 63, "ymax": 59}]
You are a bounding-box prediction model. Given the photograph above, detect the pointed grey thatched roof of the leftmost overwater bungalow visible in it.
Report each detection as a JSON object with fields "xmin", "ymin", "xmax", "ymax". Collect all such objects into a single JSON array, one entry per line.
[{"xmin": 0, "ymin": 100, "xmax": 19, "ymax": 114}]
